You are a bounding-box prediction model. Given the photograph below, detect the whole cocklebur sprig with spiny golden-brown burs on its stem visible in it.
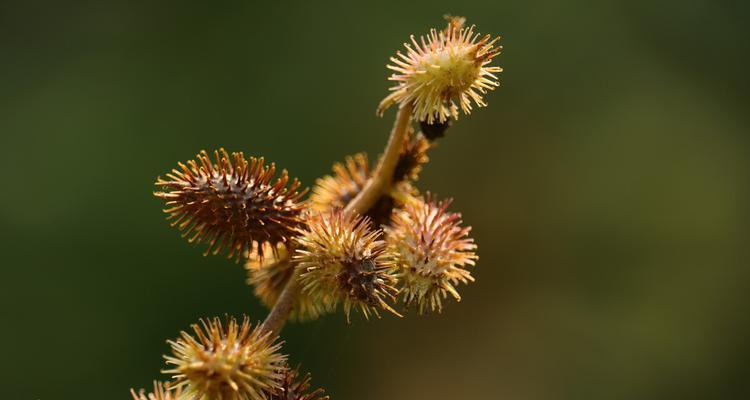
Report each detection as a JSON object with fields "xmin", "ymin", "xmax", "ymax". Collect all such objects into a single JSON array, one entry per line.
[{"xmin": 141, "ymin": 16, "xmax": 501, "ymax": 400}]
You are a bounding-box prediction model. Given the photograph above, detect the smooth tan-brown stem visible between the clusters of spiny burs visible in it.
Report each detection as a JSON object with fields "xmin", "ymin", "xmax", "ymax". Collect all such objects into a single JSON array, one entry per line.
[{"xmin": 261, "ymin": 103, "xmax": 412, "ymax": 335}]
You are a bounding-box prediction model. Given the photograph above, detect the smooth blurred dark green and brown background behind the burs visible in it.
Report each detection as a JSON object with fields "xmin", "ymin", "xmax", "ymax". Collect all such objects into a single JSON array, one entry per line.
[{"xmin": 0, "ymin": 0, "xmax": 750, "ymax": 400}]
